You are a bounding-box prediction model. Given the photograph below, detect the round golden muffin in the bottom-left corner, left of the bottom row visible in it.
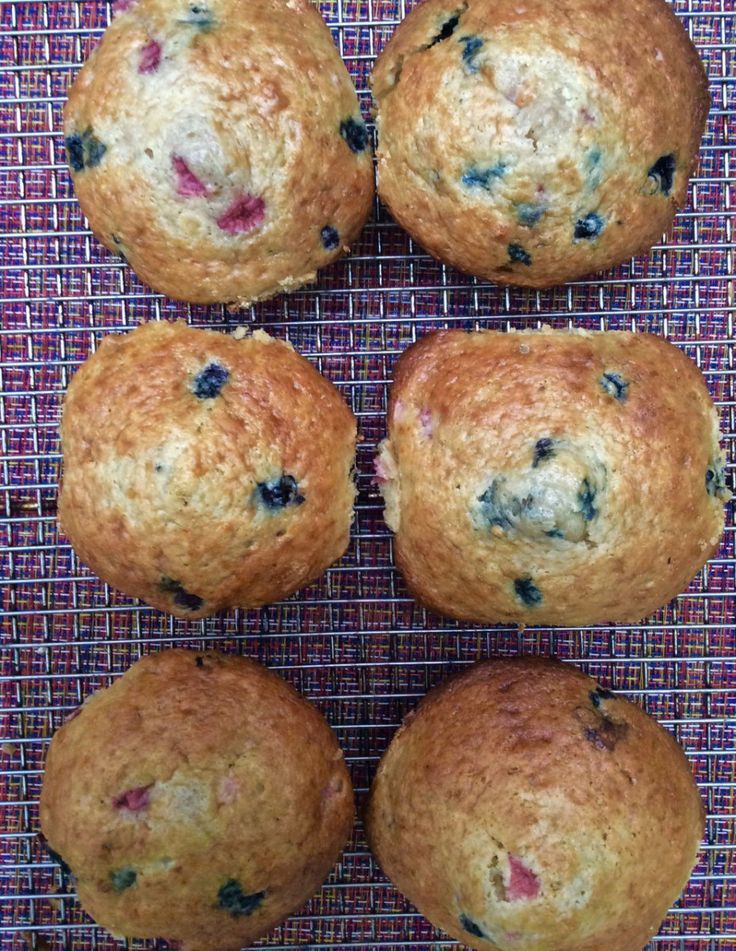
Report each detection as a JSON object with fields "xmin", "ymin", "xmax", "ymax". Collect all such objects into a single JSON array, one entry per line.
[{"xmin": 41, "ymin": 650, "xmax": 353, "ymax": 951}]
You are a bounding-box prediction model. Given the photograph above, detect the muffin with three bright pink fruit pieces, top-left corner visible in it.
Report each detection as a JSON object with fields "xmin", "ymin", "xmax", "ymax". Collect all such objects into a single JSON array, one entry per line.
[{"xmin": 64, "ymin": 0, "xmax": 373, "ymax": 306}]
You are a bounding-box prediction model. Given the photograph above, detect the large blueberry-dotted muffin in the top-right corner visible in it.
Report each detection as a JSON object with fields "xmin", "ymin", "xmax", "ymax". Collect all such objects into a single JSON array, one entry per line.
[{"xmin": 372, "ymin": 0, "xmax": 709, "ymax": 287}]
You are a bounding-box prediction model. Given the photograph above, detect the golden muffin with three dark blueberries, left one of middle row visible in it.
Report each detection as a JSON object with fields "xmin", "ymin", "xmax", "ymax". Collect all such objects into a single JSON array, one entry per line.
[{"xmin": 58, "ymin": 322, "xmax": 356, "ymax": 618}]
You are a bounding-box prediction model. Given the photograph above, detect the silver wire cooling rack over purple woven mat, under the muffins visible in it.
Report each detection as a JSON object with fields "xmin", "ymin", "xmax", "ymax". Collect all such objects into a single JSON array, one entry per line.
[{"xmin": 0, "ymin": 0, "xmax": 736, "ymax": 951}]
